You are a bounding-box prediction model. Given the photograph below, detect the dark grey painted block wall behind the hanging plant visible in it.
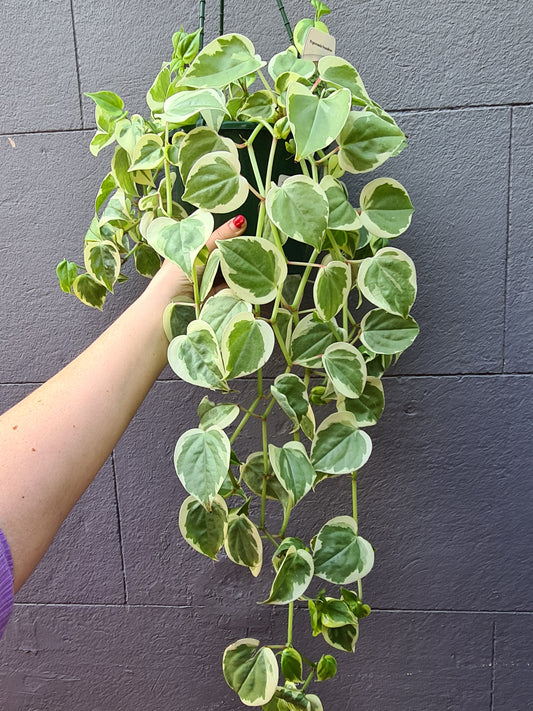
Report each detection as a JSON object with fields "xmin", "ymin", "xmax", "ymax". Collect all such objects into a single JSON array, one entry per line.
[{"xmin": 0, "ymin": 0, "xmax": 533, "ymax": 711}]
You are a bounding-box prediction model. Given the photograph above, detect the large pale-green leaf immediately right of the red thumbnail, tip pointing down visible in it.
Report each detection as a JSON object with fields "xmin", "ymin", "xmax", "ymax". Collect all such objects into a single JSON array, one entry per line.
[{"xmin": 266, "ymin": 175, "xmax": 329, "ymax": 249}]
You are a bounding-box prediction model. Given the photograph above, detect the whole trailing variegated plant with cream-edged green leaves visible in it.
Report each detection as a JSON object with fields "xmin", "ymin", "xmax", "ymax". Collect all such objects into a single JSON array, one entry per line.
[{"xmin": 58, "ymin": 0, "xmax": 418, "ymax": 711}]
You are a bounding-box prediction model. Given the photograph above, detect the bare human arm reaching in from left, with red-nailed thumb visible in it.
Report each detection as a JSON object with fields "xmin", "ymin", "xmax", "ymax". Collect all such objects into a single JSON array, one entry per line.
[{"xmin": 0, "ymin": 217, "xmax": 245, "ymax": 591}]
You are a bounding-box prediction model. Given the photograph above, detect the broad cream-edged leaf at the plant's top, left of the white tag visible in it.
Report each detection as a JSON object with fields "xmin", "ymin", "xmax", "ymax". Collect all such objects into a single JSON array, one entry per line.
[{"xmin": 180, "ymin": 34, "xmax": 265, "ymax": 89}]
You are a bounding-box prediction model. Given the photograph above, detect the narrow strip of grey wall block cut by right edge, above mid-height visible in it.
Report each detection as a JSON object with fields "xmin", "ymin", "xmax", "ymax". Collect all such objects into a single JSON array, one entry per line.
[{"xmin": 505, "ymin": 106, "xmax": 533, "ymax": 373}]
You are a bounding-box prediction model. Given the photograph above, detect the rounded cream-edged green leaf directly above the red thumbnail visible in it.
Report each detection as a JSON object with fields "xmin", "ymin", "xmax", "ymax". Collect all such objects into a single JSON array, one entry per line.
[{"xmin": 183, "ymin": 151, "xmax": 249, "ymax": 213}]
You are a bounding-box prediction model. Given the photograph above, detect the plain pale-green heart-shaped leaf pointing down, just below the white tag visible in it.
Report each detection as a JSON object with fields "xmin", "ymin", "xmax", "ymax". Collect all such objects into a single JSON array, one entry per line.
[{"xmin": 287, "ymin": 82, "xmax": 352, "ymax": 160}]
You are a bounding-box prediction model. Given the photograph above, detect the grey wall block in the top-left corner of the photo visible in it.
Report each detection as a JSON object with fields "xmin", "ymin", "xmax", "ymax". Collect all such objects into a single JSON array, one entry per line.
[{"xmin": 0, "ymin": 0, "xmax": 81, "ymax": 134}]
